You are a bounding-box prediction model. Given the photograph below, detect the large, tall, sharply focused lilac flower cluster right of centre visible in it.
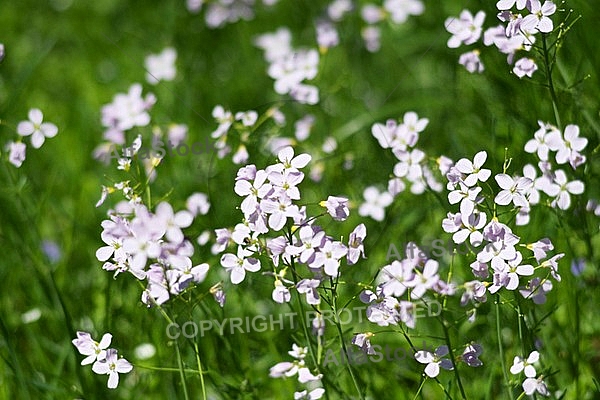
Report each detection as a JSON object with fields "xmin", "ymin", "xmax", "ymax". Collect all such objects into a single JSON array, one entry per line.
[{"xmin": 442, "ymin": 151, "xmax": 564, "ymax": 320}]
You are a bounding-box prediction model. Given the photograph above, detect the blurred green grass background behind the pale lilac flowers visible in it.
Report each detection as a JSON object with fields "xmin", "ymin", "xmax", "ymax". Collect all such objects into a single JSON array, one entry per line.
[{"xmin": 0, "ymin": 0, "xmax": 600, "ymax": 399}]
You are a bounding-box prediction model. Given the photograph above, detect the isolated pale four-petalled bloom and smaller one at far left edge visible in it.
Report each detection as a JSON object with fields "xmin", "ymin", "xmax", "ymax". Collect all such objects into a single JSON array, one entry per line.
[{"xmin": 6, "ymin": 108, "xmax": 58, "ymax": 168}]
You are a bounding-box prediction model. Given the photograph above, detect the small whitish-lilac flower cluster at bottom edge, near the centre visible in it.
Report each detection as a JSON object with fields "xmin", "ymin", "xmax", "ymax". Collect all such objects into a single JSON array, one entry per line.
[{"xmin": 269, "ymin": 343, "xmax": 325, "ymax": 400}]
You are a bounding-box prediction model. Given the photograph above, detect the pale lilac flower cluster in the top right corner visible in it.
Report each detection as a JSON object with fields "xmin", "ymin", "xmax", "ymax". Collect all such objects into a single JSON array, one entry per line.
[{"xmin": 444, "ymin": 0, "xmax": 556, "ymax": 78}]
